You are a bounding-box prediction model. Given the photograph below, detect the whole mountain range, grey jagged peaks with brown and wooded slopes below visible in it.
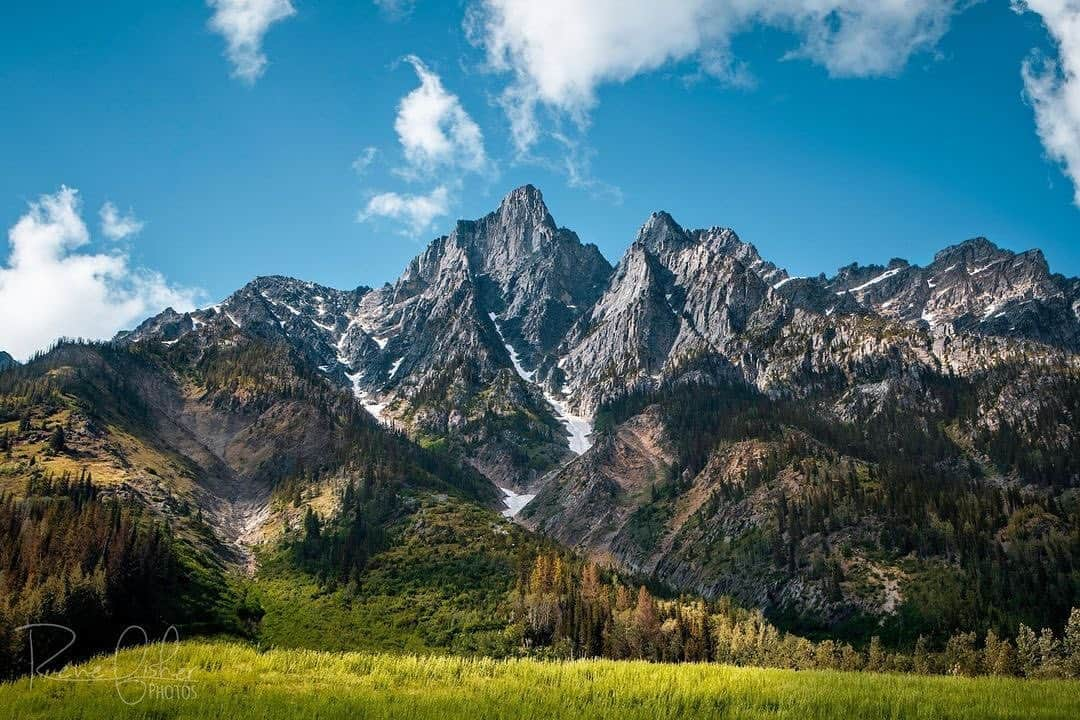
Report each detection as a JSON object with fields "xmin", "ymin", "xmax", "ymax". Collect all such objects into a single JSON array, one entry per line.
[{"xmin": 0, "ymin": 186, "xmax": 1080, "ymax": 633}]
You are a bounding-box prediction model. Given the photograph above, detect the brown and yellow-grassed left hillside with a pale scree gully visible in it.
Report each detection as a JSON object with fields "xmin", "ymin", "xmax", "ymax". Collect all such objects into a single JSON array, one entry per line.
[{"xmin": 0, "ymin": 334, "xmax": 497, "ymax": 560}]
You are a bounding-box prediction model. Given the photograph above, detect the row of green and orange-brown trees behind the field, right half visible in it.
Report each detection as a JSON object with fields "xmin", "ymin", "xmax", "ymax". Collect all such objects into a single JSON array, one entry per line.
[{"xmin": 511, "ymin": 552, "xmax": 1080, "ymax": 678}]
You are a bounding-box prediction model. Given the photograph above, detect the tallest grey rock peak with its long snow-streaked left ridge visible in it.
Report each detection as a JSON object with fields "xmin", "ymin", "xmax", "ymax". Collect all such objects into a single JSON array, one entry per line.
[{"xmin": 120, "ymin": 186, "xmax": 610, "ymax": 489}]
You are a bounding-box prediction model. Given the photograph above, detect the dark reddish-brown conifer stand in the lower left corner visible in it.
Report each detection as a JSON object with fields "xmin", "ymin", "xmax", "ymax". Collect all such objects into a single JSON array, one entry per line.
[{"xmin": 0, "ymin": 471, "xmax": 240, "ymax": 678}]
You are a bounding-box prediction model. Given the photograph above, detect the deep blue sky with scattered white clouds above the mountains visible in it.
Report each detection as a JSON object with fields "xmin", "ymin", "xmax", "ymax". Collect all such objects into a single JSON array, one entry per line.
[{"xmin": 0, "ymin": 0, "xmax": 1080, "ymax": 354}]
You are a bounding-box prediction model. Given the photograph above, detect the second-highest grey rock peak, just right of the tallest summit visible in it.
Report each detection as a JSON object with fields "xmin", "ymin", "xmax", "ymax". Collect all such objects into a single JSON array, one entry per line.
[{"xmin": 556, "ymin": 213, "xmax": 789, "ymax": 412}]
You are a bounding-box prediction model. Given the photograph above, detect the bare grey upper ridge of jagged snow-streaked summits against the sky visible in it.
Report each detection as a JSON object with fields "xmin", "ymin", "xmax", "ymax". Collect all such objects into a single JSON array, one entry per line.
[{"xmin": 118, "ymin": 185, "xmax": 1080, "ymax": 476}]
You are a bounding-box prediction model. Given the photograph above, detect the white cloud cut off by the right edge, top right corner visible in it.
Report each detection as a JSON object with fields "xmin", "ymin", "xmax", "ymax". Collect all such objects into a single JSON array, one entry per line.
[{"xmin": 1013, "ymin": 0, "xmax": 1080, "ymax": 206}]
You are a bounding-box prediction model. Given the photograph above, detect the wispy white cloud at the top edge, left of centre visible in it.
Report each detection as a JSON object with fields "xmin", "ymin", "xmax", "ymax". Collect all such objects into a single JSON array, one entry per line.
[{"xmin": 207, "ymin": 0, "xmax": 296, "ymax": 83}]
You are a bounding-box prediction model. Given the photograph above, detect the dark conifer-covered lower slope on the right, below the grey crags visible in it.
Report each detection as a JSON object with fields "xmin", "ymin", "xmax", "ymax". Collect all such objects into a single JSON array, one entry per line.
[{"xmin": 522, "ymin": 357, "xmax": 1080, "ymax": 641}]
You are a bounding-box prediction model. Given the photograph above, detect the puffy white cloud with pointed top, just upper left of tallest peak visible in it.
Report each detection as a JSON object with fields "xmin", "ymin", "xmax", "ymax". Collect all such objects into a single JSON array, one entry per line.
[{"xmin": 394, "ymin": 55, "xmax": 487, "ymax": 176}]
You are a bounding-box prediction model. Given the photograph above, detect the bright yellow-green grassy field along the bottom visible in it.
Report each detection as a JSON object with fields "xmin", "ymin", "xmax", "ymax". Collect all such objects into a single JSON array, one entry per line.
[{"xmin": 0, "ymin": 641, "xmax": 1080, "ymax": 720}]
